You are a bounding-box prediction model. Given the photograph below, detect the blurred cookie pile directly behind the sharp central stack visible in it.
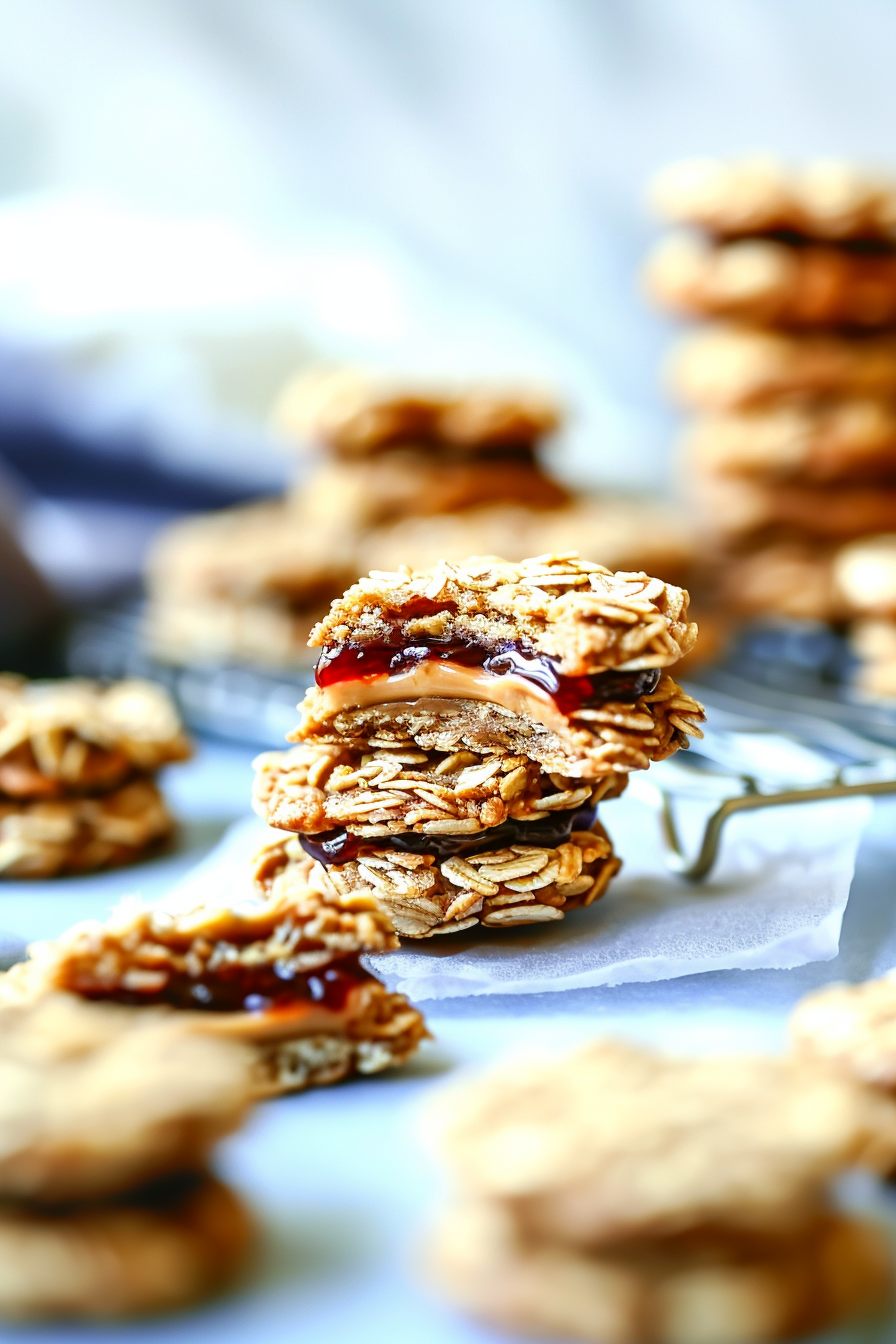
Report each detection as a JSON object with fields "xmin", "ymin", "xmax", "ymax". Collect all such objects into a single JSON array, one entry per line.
[{"xmin": 145, "ymin": 370, "xmax": 693, "ymax": 668}]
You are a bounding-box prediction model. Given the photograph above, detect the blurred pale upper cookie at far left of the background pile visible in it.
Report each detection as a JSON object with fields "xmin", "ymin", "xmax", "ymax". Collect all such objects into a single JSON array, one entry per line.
[{"xmin": 146, "ymin": 500, "xmax": 357, "ymax": 607}]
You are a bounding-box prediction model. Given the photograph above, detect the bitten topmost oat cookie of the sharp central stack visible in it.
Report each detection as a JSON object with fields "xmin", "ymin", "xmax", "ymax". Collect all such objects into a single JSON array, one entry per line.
[{"xmin": 309, "ymin": 551, "xmax": 697, "ymax": 676}]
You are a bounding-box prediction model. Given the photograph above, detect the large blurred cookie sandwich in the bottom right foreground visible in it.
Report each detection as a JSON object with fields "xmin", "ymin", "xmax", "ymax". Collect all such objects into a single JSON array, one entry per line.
[{"xmin": 426, "ymin": 1042, "xmax": 896, "ymax": 1344}]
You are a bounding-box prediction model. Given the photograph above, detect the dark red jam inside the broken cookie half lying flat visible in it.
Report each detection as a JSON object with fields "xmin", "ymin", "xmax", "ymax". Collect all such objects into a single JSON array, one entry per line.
[{"xmin": 71, "ymin": 956, "xmax": 375, "ymax": 1013}]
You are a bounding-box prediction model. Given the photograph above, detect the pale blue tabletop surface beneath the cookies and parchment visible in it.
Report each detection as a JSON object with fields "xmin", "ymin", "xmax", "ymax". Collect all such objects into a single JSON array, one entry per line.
[{"xmin": 0, "ymin": 743, "xmax": 896, "ymax": 1344}]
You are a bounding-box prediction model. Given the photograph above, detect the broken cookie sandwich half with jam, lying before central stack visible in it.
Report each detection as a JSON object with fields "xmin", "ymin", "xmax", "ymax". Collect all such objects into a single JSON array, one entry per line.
[{"xmin": 7, "ymin": 859, "xmax": 427, "ymax": 1095}]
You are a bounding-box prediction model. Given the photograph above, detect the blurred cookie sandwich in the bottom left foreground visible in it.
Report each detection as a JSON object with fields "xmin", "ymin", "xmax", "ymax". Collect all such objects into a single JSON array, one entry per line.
[{"xmin": 0, "ymin": 995, "xmax": 251, "ymax": 1318}]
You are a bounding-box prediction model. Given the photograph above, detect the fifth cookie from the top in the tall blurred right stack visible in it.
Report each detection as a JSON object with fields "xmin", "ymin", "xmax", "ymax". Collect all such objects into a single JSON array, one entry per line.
[{"xmin": 690, "ymin": 474, "xmax": 896, "ymax": 543}]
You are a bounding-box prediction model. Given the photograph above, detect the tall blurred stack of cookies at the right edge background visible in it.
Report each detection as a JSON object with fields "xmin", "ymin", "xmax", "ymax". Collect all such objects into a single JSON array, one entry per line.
[{"xmin": 646, "ymin": 160, "xmax": 896, "ymax": 620}]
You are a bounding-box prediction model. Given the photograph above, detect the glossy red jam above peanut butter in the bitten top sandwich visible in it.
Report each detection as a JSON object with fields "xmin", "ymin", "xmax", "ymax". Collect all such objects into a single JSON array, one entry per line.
[{"xmin": 314, "ymin": 637, "xmax": 661, "ymax": 716}]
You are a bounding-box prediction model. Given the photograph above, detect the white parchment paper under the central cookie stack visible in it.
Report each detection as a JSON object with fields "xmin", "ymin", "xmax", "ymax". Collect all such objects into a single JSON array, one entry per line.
[{"xmin": 167, "ymin": 794, "xmax": 870, "ymax": 1000}]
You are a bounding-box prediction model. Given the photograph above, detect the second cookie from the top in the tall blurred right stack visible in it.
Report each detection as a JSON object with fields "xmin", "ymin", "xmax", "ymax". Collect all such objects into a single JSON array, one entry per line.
[{"xmin": 645, "ymin": 234, "xmax": 896, "ymax": 329}]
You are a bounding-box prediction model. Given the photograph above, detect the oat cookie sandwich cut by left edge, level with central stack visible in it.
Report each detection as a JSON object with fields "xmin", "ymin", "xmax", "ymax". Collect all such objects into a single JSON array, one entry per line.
[{"xmin": 0, "ymin": 676, "xmax": 191, "ymax": 878}]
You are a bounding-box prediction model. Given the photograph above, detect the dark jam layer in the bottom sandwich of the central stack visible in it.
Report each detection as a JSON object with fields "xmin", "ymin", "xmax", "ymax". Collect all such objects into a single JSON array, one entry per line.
[{"xmin": 298, "ymin": 804, "xmax": 598, "ymax": 864}]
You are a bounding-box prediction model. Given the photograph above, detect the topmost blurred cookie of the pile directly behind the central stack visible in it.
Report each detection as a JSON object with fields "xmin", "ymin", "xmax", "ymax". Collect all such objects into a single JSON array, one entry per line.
[{"xmin": 274, "ymin": 368, "xmax": 560, "ymax": 457}]
